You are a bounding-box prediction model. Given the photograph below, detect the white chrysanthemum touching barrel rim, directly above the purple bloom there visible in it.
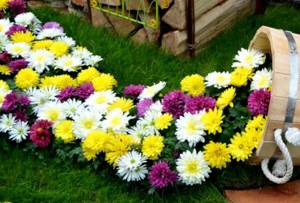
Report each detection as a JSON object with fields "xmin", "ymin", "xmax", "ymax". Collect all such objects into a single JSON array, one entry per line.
[{"xmin": 251, "ymin": 68, "xmax": 272, "ymax": 90}]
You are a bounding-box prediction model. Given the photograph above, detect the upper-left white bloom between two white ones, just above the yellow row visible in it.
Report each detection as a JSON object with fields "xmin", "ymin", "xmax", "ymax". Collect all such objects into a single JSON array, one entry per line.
[{"xmin": 55, "ymin": 55, "xmax": 82, "ymax": 72}]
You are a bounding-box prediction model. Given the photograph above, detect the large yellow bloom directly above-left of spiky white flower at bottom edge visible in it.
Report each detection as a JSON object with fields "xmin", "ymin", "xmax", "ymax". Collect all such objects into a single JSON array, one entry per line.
[{"xmin": 105, "ymin": 134, "xmax": 135, "ymax": 167}]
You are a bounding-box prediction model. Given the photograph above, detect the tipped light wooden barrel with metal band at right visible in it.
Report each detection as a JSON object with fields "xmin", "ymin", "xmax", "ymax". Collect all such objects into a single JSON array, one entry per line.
[{"xmin": 249, "ymin": 26, "xmax": 300, "ymax": 165}]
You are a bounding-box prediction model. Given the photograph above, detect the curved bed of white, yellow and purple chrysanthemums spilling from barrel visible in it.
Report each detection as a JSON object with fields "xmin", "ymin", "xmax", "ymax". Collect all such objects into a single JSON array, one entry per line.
[{"xmin": 0, "ymin": 0, "xmax": 272, "ymax": 189}]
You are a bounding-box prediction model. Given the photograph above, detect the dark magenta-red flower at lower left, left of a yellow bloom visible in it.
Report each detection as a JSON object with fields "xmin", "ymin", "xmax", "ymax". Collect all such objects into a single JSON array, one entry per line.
[{"xmin": 29, "ymin": 120, "xmax": 52, "ymax": 148}]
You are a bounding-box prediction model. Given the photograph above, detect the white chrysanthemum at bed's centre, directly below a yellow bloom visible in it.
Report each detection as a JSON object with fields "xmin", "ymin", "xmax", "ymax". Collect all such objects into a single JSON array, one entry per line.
[{"xmin": 103, "ymin": 109, "xmax": 133, "ymax": 133}]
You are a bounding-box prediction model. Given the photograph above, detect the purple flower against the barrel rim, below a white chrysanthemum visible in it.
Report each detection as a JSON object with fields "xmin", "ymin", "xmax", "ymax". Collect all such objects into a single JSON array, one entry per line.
[{"xmin": 247, "ymin": 89, "xmax": 271, "ymax": 116}]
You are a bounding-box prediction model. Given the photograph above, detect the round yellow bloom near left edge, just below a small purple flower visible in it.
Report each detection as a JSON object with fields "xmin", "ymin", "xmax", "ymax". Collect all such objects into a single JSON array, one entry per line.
[{"xmin": 15, "ymin": 68, "xmax": 40, "ymax": 89}]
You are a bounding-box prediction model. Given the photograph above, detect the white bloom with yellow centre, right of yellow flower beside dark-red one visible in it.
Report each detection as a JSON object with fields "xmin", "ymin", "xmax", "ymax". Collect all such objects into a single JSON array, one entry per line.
[{"xmin": 73, "ymin": 109, "xmax": 102, "ymax": 139}]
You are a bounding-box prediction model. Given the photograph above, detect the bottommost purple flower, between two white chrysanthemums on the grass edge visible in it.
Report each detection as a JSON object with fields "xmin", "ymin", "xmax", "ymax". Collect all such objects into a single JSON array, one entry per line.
[{"xmin": 148, "ymin": 161, "xmax": 177, "ymax": 189}]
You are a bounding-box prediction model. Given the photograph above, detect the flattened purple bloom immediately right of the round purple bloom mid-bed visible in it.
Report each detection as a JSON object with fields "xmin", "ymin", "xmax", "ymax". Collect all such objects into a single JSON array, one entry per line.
[{"xmin": 185, "ymin": 96, "xmax": 216, "ymax": 114}]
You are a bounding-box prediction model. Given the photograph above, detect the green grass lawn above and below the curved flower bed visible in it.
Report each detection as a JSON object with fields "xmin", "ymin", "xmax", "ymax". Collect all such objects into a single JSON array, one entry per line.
[{"xmin": 0, "ymin": 5, "xmax": 300, "ymax": 202}]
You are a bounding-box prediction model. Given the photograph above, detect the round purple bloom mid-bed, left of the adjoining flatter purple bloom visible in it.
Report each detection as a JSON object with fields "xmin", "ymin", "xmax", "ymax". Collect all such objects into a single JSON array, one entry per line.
[{"xmin": 162, "ymin": 90, "xmax": 188, "ymax": 118}]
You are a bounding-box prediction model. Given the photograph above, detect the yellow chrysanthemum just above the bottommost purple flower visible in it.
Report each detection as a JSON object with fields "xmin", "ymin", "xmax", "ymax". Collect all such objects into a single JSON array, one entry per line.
[{"xmin": 142, "ymin": 135, "xmax": 165, "ymax": 160}]
